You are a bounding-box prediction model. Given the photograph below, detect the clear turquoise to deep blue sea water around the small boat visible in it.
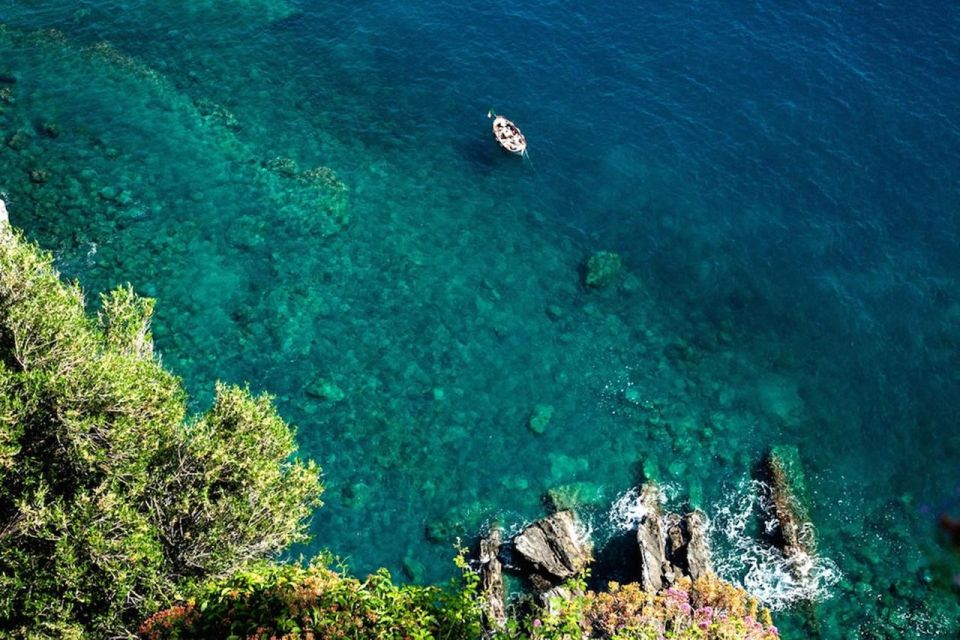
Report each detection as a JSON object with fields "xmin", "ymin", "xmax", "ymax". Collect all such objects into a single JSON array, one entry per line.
[{"xmin": 0, "ymin": 0, "xmax": 960, "ymax": 637}]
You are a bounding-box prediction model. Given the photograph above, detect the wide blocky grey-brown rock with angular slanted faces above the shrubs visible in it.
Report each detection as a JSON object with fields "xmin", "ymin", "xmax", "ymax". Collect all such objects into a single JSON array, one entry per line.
[{"xmin": 513, "ymin": 511, "xmax": 591, "ymax": 580}]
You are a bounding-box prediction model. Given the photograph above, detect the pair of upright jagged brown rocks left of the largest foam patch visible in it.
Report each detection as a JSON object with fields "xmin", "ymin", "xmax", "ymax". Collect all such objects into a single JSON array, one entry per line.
[{"xmin": 637, "ymin": 483, "xmax": 711, "ymax": 592}]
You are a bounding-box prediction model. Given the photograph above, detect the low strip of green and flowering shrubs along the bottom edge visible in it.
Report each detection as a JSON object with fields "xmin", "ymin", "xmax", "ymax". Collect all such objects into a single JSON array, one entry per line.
[{"xmin": 141, "ymin": 562, "xmax": 779, "ymax": 640}]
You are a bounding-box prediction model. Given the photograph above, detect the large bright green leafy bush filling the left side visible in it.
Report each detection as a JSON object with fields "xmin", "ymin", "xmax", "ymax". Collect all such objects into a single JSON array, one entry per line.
[{"xmin": 0, "ymin": 227, "xmax": 321, "ymax": 637}]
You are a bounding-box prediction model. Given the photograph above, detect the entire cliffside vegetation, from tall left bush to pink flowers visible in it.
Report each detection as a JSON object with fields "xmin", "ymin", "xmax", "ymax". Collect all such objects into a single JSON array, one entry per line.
[{"xmin": 0, "ymin": 222, "xmax": 777, "ymax": 640}]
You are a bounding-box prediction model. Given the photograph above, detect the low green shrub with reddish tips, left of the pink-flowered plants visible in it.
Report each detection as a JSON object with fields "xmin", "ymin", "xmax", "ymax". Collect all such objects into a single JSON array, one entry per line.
[{"xmin": 140, "ymin": 563, "xmax": 481, "ymax": 640}]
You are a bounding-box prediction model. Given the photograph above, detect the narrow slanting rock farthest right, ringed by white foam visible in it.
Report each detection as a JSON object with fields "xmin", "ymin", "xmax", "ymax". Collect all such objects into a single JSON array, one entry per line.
[{"xmin": 764, "ymin": 446, "xmax": 816, "ymax": 578}]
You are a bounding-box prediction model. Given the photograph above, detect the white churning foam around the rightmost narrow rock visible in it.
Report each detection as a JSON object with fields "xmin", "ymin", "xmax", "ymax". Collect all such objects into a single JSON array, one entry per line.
[{"xmin": 712, "ymin": 480, "xmax": 841, "ymax": 610}]
